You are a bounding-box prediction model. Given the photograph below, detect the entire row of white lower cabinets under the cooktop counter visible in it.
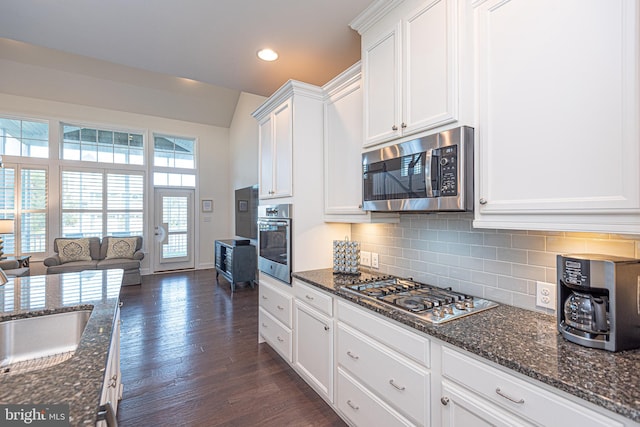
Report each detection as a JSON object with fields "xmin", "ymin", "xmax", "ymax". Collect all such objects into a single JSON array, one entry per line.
[{"xmin": 274, "ymin": 288, "xmax": 640, "ymax": 427}]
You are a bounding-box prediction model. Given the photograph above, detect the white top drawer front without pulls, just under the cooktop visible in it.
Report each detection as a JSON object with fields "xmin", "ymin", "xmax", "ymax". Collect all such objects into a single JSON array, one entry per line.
[{"xmin": 337, "ymin": 301, "xmax": 430, "ymax": 368}]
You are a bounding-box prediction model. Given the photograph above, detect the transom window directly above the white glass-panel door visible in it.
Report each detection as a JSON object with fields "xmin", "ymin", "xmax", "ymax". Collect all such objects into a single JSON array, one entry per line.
[{"xmin": 153, "ymin": 135, "xmax": 196, "ymax": 187}]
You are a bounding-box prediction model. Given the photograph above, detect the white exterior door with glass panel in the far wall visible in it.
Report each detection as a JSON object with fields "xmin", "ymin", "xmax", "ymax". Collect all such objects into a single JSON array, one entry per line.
[{"xmin": 154, "ymin": 188, "xmax": 194, "ymax": 271}]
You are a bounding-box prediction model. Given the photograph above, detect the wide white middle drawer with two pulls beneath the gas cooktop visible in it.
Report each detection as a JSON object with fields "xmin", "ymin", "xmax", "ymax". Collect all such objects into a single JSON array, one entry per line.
[{"xmin": 338, "ymin": 324, "xmax": 430, "ymax": 425}]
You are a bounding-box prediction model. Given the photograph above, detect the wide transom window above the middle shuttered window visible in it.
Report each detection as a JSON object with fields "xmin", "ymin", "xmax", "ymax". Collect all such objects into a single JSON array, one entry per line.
[{"xmin": 62, "ymin": 123, "xmax": 144, "ymax": 165}]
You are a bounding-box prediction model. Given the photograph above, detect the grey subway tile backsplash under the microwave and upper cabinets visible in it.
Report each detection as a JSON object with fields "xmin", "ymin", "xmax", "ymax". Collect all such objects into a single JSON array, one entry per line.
[{"xmin": 351, "ymin": 213, "xmax": 640, "ymax": 314}]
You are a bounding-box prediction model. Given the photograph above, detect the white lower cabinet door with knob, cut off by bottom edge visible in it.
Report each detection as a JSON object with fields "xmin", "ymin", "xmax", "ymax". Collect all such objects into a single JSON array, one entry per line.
[{"xmin": 440, "ymin": 382, "xmax": 533, "ymax": 427}]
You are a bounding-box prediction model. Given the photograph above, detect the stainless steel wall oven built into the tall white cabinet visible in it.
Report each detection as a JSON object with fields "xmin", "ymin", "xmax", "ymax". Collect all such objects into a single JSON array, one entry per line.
[{"xmin": 258, "ymin": 205, "xmax": 292, "ymax": 284}]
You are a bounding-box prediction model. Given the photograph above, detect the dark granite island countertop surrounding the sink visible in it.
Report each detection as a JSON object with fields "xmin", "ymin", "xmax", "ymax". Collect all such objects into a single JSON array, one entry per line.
[{"xmin": 0, "ymin": 270, "xmax": 123, "ymax": 426}]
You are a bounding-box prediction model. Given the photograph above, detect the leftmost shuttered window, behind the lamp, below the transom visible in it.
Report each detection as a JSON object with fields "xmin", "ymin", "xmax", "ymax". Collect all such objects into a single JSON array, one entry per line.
[{"xmin": 0, "ymin": 166, "xmax": 47, "ymax": 255}]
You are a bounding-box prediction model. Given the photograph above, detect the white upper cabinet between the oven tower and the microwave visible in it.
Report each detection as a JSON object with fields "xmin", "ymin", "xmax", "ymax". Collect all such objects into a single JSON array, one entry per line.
[{"xmin": 323, "ymin": 63, "xmax": 399, "ymax": 223}]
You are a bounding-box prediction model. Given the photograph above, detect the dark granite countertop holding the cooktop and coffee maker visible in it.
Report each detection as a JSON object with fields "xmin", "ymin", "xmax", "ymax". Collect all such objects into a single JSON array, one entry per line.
[{"xmin": 293, "ymin": 269, "xmax": 640, "ymax": 422}]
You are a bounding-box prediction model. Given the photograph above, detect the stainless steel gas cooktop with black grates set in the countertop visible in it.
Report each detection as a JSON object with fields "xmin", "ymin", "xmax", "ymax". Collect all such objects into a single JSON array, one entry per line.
[{"xmin": 342, "ymin": 276, "xmax": 498, "ymax": 324}]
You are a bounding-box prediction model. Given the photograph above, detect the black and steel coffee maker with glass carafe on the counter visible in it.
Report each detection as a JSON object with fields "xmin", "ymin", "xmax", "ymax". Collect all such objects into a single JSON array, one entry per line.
[{"xmin": 557, "ymin": 254, "xmax": 640, "ymax": 351}]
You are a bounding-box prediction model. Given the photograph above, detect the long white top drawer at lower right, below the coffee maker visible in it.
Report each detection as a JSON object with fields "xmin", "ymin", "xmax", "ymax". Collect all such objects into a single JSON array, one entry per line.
[{"xmin": 442, "ymin": 348, "xmax": 622, "ymax": 427}]
